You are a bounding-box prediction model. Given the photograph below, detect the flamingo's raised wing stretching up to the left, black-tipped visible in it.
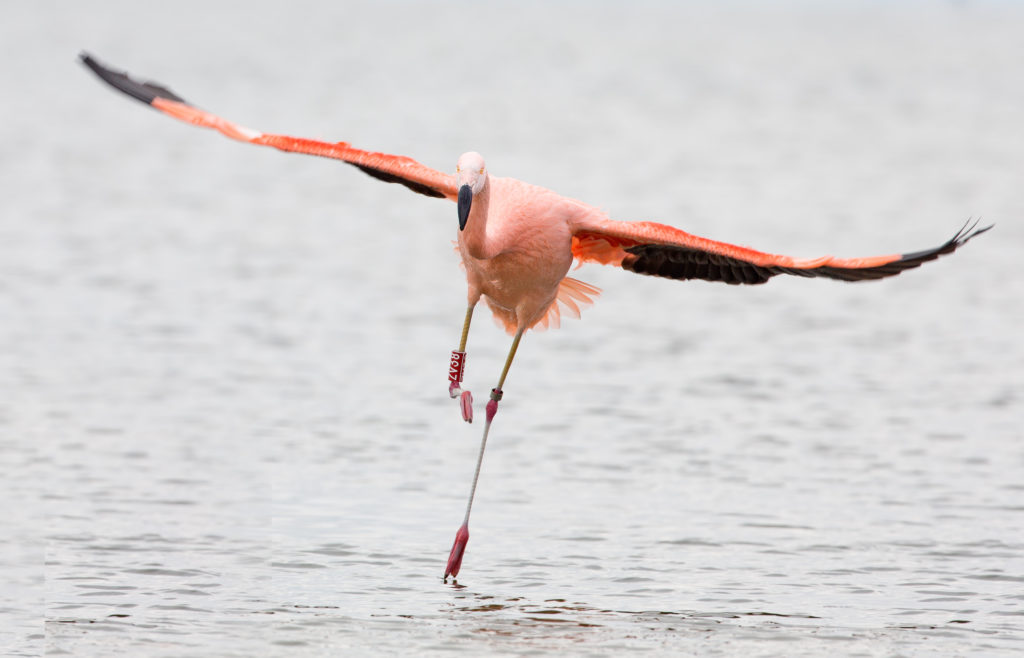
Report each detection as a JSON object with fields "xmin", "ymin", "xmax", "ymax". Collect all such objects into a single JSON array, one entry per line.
[{"xmin": 80, "ymin": 52, "xmax": 459, "ymax": 201}]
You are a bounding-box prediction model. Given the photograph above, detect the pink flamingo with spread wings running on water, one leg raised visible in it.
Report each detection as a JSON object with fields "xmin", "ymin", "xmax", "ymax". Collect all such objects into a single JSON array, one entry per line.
[{"xmin": 80, "ymin": 52, "xmax": 992, "ymax": 582}]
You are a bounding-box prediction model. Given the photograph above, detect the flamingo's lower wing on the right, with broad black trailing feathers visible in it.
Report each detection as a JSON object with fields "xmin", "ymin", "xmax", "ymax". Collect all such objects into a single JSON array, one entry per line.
[{"xmin": 572, "ymin": 218, "xmax": 991, "ymax": 284}]
